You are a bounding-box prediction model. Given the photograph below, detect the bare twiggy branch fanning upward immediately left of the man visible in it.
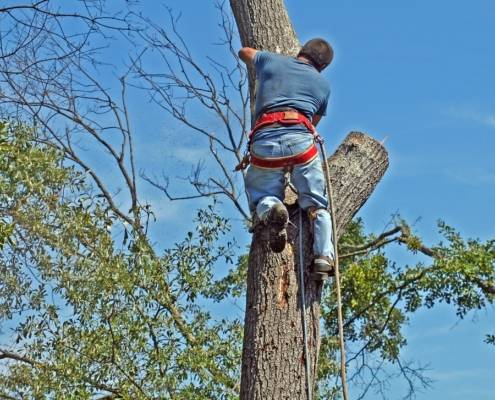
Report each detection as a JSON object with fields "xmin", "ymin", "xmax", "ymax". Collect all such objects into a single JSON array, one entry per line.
[{"xmin": 129, "ymin": 4, "xmax": 249, "ymax": 218}]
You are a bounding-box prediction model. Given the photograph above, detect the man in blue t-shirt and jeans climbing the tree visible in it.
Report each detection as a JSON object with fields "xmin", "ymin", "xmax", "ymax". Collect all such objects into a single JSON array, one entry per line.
[{"xmin": 239, "ymin": 39, "xmax": 333, "ymax": 279}]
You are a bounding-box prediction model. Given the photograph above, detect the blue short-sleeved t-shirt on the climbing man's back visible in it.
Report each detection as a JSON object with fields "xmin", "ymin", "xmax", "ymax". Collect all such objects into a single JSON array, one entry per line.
[{"xmin": 254, "ymin": 51, "xmax": 330, "ymax": 120}]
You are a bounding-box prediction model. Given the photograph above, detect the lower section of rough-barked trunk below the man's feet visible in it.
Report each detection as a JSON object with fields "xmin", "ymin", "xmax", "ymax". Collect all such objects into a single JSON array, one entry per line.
[{"xmin": 241, "ymin": 211, "xmax": 322, "ymax": 400}]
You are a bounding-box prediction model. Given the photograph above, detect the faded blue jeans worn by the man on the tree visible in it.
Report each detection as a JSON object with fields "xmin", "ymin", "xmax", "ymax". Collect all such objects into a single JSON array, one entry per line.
[{"xmin": 246, "ymin": 131, "xmax": 333, "ymax": 257}]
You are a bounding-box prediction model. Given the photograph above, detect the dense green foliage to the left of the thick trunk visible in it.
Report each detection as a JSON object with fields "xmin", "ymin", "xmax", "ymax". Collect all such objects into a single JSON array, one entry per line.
[{"xmin": 0, "ymin": 124, "xmax": 241, "ymax": 399}]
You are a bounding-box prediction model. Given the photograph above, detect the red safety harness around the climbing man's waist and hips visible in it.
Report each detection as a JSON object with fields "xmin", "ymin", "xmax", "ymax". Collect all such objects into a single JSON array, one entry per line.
[{"xmin": 235, "ymin": 110, "xmax": 318, "ymax": 171}]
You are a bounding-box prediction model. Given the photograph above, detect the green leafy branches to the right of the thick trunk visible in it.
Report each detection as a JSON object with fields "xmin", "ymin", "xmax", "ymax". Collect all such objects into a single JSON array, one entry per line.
[{"xmin": 319, "ymin": 220, "xmax": 495, "ymax": 399}]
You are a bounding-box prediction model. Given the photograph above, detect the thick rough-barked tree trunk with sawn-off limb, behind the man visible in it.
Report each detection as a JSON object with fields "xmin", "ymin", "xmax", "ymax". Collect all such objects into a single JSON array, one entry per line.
[{"xmin": 230, "ymin": 0, "xmax": 388, "ymax": 400}]
